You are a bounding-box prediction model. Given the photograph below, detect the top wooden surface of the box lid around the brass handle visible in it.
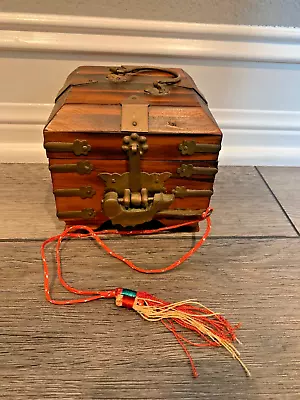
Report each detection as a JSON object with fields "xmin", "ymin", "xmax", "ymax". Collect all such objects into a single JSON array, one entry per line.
[{"xmin": 54, "ymin": 66, "xmax": 202, "ymax": 106}]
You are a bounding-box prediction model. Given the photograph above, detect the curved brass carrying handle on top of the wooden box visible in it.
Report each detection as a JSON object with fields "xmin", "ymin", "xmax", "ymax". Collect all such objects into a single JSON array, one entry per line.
[{"xmin": 109, "ymin": 65, "xmax": 181, "ymax": 95}]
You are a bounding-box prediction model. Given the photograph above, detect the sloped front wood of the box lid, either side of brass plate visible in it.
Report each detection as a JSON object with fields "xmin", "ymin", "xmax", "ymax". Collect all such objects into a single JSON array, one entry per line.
[{"xmin": 45, "ymin": 104, "xmax": 221, "ymax": 135}]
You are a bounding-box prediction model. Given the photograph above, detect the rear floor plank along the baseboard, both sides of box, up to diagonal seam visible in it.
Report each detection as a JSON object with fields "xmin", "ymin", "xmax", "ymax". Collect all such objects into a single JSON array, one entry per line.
[{"xmin": 0, "ymin": 164, "xmax": 297, "ymax": 239}]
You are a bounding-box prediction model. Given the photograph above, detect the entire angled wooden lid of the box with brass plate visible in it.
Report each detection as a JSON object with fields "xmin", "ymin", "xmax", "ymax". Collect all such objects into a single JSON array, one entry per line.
[{"xmin": 44, "ymin": 66, "xmax": 221, "ymax": 135}]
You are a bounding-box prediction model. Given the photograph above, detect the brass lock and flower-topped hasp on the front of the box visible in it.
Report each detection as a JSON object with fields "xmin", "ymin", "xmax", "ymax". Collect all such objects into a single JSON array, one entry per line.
[{"xmin": 98, "ymin": 133, "xmax": 175, "ymax": 227}]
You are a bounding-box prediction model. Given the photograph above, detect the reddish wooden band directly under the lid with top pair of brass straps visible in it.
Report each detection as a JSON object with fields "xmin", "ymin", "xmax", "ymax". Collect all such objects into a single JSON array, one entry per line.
[{"xmin": 44, "ymin": 133, "xmax": 221, "ymax": 161}]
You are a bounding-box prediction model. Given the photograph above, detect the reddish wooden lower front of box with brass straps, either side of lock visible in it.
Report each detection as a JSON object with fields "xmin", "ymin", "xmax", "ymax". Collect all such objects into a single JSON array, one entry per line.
[{"xmin": 49, "ymin": 159, "xmax": 217, "ymax": 222}]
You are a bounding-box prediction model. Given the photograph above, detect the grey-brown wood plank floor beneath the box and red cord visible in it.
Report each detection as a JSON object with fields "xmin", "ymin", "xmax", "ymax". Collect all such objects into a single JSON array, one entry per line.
[{"xmin": 0, "ymin": 164, "xmax": 300, "ymax": 400}]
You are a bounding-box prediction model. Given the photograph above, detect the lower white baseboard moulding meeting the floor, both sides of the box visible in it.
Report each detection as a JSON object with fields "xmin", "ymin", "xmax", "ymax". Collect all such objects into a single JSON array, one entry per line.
[{"xmin": 0, "ymin": 103, "xmax": 300, "ymax": 166}]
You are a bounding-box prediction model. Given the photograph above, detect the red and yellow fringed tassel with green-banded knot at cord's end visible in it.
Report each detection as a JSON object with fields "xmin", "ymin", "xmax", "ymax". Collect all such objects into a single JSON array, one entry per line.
[{"xmin": 116, "ymin": 289, "xmax": 251, "ymax": 377}]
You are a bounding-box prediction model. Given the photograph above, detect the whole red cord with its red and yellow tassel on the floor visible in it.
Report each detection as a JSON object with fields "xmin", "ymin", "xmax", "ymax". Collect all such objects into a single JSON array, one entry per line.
[{"xmin": 41, "ymin": 208, "xmax": 250, "ymax": 377}]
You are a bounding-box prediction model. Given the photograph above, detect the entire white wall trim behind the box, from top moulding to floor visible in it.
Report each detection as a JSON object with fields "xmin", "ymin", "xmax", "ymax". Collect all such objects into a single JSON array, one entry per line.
[{"xmin": 0, "ymin": 13, "xmax": 300, "ymax": 165}]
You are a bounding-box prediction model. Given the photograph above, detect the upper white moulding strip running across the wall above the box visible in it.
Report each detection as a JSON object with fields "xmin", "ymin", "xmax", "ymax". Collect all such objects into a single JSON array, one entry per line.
[{"xmin": 0, "ymin": 13, "xmax": 300, "ymax": 63}]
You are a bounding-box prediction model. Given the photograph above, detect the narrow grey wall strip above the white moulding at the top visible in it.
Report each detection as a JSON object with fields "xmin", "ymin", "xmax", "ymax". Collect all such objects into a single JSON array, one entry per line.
[{"xmin": 0, "ymin": 0, "xmax": 300, "ymax": 27}]
